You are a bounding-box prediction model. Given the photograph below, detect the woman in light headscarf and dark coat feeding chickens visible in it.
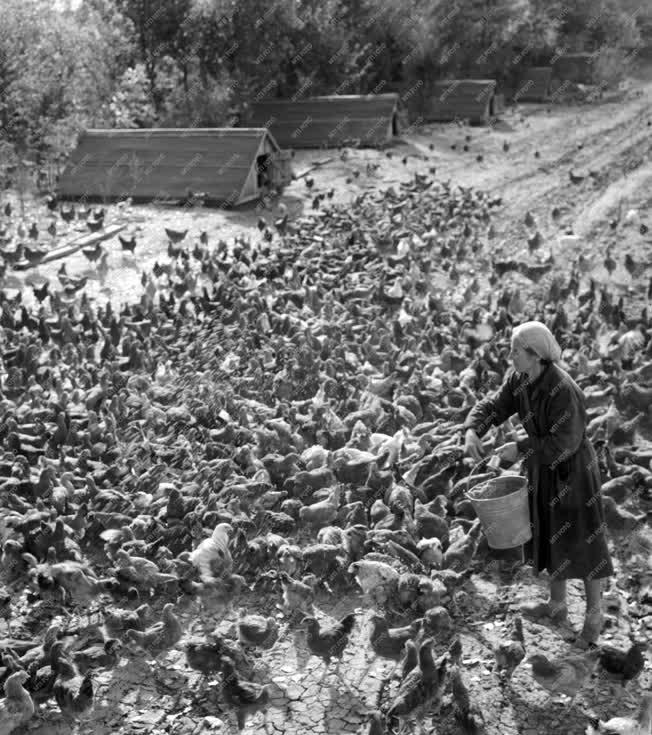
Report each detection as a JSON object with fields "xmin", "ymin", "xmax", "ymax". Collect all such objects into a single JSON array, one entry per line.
[{"xmin": 464, "ymin": 321, "xmax": 613, "ymax": 645}]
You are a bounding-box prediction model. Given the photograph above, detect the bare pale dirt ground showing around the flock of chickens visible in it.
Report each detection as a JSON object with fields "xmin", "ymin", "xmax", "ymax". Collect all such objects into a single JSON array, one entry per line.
[{"xmin": 9, "ymin": 63, "xmax": 652, "ymax": 735}]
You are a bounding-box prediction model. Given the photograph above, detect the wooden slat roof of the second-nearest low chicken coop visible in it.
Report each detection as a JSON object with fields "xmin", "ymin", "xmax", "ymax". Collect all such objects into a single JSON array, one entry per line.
[{"xmin": 249, "ymin": 92, "xmax": 399, "ymax": 148}]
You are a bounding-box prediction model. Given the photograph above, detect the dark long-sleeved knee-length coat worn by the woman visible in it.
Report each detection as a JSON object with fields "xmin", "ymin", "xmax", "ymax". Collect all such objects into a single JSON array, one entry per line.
[{"xmin": 465, "ymin": 363, "xmax": 614, "ymax": 579}]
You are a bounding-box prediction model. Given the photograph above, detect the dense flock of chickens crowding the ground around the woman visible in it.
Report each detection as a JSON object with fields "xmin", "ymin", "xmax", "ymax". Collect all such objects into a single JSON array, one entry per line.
[{"xmin": 0, "ymin": 170, "xmax": 652, "ymax": 735}]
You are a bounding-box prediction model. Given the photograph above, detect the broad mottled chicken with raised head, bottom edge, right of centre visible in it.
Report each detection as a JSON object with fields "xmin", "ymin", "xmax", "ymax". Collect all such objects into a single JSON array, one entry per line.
[{"xmin": 387, "ymin": 638, "xmax": 448, "ymax": 732}]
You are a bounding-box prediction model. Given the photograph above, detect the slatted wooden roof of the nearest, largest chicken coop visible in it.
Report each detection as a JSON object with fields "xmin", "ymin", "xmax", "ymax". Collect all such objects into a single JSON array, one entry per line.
[{"xmin": 58, "ymin": 128, "xmax": 278, "ymax": 201}]
